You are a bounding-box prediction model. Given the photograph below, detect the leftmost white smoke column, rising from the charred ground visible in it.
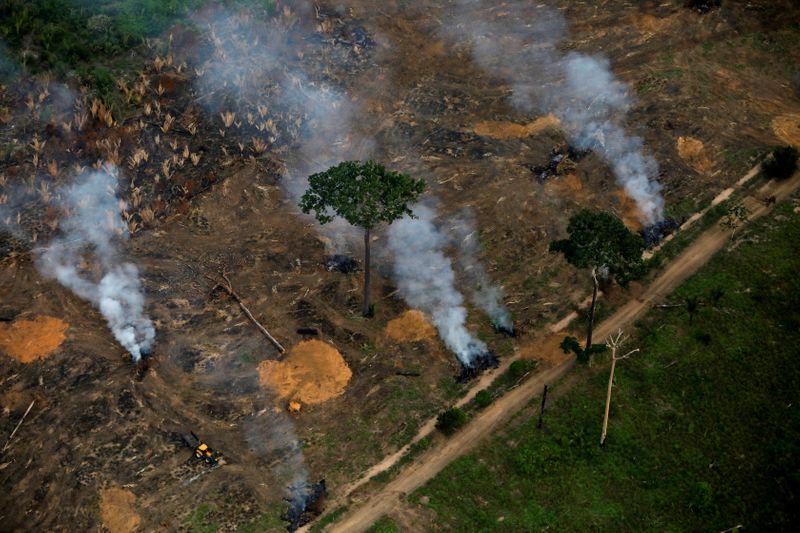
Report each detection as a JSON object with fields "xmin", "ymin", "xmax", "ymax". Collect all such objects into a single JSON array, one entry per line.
[{"xmin": 35, "ymin": 168, "xmax": 155, "ymax": 361}]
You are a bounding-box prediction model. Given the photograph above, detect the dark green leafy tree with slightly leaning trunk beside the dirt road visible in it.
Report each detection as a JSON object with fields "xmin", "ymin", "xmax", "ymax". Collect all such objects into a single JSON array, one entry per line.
[{"xmin": 550, "ymin": 209, "xmax": 644, "ymax": 352}]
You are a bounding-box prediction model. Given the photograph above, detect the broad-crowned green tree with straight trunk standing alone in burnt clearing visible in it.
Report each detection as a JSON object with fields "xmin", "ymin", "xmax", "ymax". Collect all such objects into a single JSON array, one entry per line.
[{"xmin": 300, "ymin": 161, "xmax": 425, "ymax": 316}]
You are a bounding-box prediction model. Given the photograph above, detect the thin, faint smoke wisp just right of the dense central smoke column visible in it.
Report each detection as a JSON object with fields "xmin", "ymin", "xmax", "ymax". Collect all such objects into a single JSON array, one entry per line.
[{"xmin": 450, "ymin": 209, "xmax": 514, "ymax": 331}]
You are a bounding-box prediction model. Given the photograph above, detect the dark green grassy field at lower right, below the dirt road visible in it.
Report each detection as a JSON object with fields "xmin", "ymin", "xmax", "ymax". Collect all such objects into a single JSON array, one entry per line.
[{"xmin": 413, "ymin": 199, "xmax": 800, "ymax": 531}]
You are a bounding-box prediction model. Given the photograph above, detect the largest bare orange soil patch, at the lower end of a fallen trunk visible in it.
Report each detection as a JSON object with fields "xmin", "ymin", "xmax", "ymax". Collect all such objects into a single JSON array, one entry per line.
[{"xmin": 258, "ymin": 340, "xmax": 353, "ymax": 404}]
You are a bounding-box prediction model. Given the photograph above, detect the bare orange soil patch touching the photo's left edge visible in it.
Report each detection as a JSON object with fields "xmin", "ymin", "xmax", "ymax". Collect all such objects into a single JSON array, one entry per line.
[{"xmin": 0, "ymin": 315, "xmax": 69, "ymax": 363}]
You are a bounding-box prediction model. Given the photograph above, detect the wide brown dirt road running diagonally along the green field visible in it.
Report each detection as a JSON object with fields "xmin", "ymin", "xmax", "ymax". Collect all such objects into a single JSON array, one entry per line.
[{"xmin": 328, "ymin": 173, "xmax": 800, "ymax": 533}]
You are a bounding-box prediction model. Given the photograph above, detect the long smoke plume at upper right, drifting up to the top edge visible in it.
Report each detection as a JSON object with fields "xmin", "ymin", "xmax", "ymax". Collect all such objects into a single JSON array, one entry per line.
[{"xmin": 445, "ymin": 0, "xmax": 664, "ymax": 224}]
